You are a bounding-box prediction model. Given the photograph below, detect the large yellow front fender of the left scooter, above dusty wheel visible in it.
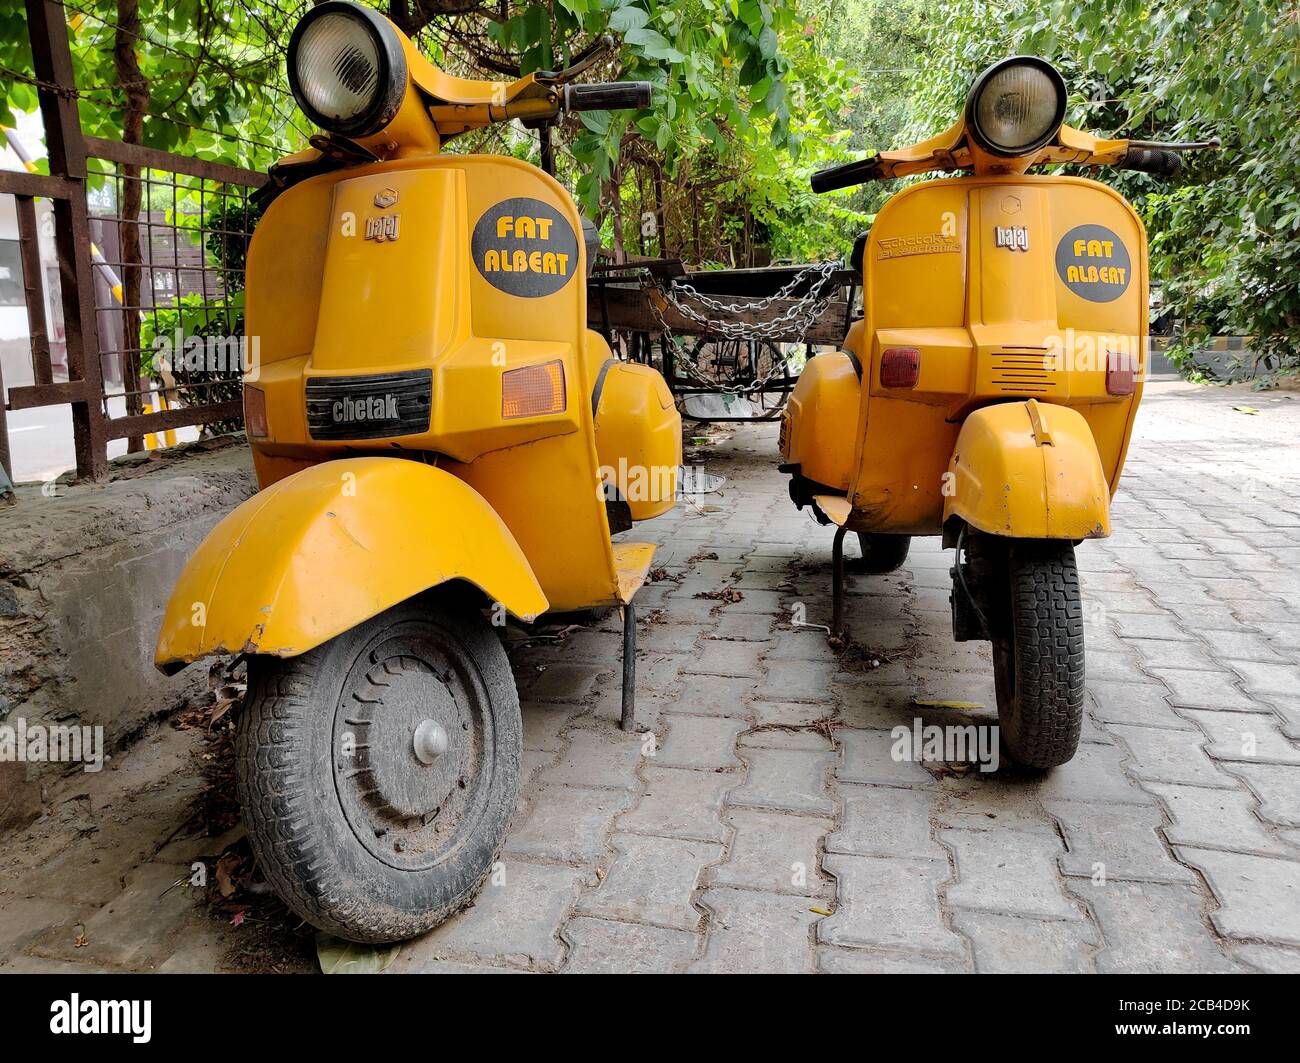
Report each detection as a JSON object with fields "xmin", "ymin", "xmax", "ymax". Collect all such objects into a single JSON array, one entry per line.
[{"xmin": 153, "ymin": 457, "xmax": 547, "ymax": 673}]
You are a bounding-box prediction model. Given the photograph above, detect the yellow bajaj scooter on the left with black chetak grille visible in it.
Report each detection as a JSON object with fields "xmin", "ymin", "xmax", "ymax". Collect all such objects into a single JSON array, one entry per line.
[{"xmin": 156, "ymin": 3, "xmax": 681, "ymax": 941}]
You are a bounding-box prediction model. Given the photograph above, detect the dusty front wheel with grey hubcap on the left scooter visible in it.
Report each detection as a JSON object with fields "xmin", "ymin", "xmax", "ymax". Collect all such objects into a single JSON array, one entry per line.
[{"xmin": 235, "ymin": 599, "xmax": 523, "ymax": 942}]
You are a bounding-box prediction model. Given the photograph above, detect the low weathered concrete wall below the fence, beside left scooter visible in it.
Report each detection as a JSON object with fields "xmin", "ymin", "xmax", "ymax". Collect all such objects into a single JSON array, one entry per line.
[{"xmin": 0, "ymin": 444, "xmax": 255, "ymax": 825}]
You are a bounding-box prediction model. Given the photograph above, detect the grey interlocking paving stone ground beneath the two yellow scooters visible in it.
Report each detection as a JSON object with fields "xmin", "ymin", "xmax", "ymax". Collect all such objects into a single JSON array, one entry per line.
[{"xmin": 0, "ymin": 383, "xmax": 1300, "ymax": 972}]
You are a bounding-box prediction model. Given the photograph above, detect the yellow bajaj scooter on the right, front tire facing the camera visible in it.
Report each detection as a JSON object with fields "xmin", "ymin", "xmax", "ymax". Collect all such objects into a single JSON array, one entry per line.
[{"xmin": 781, "ymin": 57, "xmax": 1214, "ymax": 768}]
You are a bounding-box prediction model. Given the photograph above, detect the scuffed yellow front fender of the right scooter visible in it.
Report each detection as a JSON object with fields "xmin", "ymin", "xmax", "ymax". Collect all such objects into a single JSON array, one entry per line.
[{"xmin": 944, "ymin": 399, "xmax": 1110, "ymax": 539}]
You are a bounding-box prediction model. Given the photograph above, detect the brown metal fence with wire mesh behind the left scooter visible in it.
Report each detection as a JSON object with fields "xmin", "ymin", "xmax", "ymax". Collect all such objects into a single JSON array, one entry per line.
[{"xmin": 0, "ymin": 0, "xmax": 265, "ymax": 480}]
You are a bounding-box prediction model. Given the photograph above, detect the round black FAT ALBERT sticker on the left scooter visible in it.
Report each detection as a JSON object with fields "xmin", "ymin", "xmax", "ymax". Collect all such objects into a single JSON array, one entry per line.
[{"xmin": 469, "ymin": 196, "xmax": 579, "ymax": 299}]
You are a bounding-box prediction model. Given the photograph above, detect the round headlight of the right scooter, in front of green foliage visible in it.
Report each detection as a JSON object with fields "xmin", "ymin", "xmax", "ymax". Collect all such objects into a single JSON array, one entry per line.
[{"xmin": 966, "ymin": 56, "xmax": 1065, "ymax": 157}]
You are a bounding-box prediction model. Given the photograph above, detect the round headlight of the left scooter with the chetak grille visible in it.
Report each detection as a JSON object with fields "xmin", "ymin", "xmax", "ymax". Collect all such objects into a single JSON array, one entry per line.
[{"xmin": 289, "ymin": 0, "xmax": 407, "ymax": 136}]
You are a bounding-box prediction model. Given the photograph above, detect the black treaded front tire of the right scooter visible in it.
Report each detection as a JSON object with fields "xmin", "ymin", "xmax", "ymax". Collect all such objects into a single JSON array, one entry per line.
[{"xmin": 993, "ymin": 541, "xmax": 1084, "ymax": 771}]
